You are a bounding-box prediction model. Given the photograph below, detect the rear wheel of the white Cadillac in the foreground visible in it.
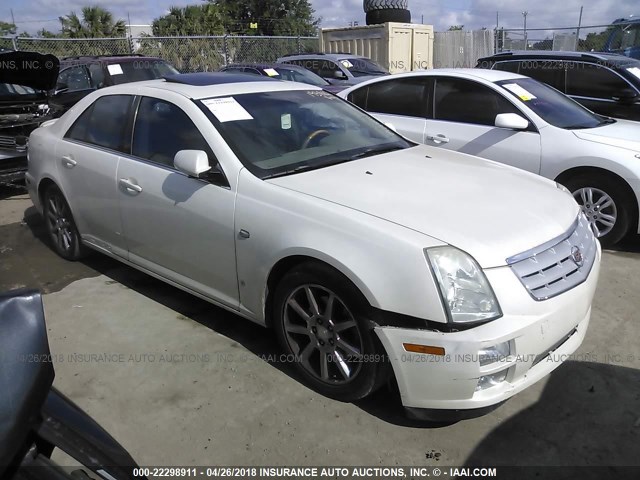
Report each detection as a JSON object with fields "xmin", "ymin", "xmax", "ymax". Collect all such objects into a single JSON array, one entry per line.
[{"xmin": 43, "ymin": 185, "xmax": 87, "ymax": 261}]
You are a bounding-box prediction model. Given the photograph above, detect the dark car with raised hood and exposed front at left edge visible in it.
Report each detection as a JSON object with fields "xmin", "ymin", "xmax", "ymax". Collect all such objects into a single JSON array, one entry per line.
[{"xmin": 0, "ymin": 50, "xmax": 60, "ymax": 185}]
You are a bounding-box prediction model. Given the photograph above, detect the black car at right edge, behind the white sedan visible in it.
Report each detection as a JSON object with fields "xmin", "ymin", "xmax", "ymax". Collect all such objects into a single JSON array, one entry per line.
[{"xmin": 476, "ymin": 50, "xmax": 640, "ymax": 121}]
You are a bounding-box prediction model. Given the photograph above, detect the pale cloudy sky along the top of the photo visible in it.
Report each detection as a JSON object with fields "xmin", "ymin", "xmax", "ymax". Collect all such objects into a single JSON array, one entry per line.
[{"xmin": 0, "ymin": 0, "xmax": 640, "ymax": 33}]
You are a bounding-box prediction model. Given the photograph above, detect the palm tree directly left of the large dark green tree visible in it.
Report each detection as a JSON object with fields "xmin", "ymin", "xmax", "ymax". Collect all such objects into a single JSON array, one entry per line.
[{"xmin": 151, "ymin": 3, "xmax": 224, "ymax": 37}]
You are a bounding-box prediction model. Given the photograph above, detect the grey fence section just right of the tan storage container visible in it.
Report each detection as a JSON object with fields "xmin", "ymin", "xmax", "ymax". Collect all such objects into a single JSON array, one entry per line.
[{"xmin": 433, "ymin": 30, "xmax": 495, "ymax": 68}]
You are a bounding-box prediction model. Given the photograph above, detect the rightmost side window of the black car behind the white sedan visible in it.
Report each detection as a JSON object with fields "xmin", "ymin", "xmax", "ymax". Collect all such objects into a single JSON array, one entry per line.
[{"xmin": 567, "ymin": 63, "xmax": 629, "ymax": 99}]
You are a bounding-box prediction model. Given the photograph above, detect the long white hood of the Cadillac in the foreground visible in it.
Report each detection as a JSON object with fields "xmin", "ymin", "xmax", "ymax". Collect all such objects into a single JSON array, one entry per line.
[{"xmin": 267, "ymin": 145, "xmax": 579, "ymax": 268}]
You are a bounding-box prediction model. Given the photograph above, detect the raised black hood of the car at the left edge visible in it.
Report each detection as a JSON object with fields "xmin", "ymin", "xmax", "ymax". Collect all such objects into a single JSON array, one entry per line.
[{"xmin": 0, "ymin": 52, "xmax": 60, "ymax": 90}]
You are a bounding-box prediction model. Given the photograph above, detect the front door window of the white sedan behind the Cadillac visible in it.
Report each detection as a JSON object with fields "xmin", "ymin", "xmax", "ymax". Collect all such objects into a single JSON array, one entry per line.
[{"xmin": 433, "ymin": 77, "xmax": 522, "ymax": 126}]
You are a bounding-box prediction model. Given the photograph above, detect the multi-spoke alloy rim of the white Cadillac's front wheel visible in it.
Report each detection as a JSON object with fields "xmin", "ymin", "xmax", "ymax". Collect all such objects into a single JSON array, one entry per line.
[{"xmin": 284, "ymin": 284, "xmax": 364, "ymax": 385}]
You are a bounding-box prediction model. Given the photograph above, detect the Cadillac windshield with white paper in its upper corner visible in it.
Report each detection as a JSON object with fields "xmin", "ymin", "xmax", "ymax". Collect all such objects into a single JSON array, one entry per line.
[{"xmin": 199, "ymin": 90, "xmax": 413, "ymax": 179}]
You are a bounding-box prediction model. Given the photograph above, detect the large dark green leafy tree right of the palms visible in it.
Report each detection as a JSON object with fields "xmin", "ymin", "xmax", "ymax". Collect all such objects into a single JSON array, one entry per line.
[{"xmin": 207, "ymin": 0, "xmax": 320, "ymax": 36}]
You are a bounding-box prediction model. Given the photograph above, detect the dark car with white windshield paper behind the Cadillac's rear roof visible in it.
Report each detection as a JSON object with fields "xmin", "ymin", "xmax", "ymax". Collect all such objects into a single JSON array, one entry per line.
[{"xmin": 51, "ymin": 55, "xmax": 179, "ymax": 115}]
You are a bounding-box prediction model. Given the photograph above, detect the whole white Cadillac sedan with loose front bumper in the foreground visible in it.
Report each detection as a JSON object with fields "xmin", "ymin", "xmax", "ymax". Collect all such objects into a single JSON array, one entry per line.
[{"xmin": 27, "ymin": 74, "xmax": 600, "ymax": 418}]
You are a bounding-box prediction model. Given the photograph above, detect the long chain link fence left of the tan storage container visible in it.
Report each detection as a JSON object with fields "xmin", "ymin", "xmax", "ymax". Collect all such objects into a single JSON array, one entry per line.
[{"xmin": 6, "ymin": 35, "xmax": 319, "ymax": 73}]
